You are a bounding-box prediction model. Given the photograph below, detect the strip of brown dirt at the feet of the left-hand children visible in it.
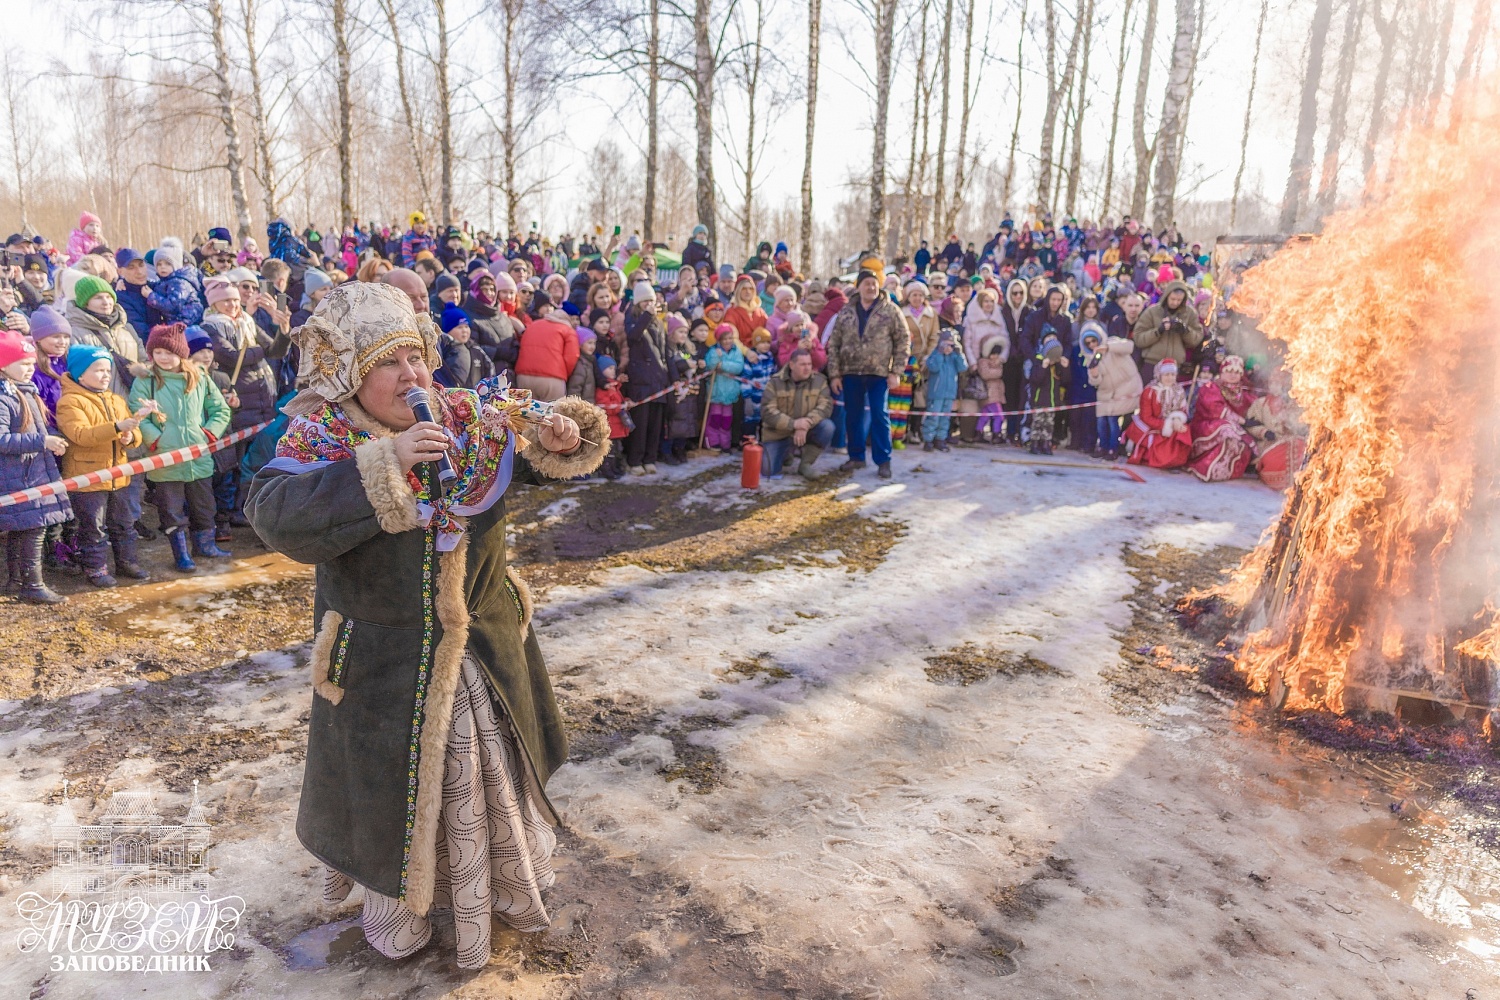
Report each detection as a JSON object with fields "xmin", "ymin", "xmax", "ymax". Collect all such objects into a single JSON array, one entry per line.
[{"xmin": 0, "ymin": 528, "xmax": 312, "ymax": 700}]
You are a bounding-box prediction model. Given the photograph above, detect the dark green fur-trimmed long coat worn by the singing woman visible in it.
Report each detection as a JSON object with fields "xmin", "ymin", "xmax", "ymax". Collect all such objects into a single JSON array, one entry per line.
[{"xmin": 245, "ymin": 399, "xmax": 609, "ymax": 913}]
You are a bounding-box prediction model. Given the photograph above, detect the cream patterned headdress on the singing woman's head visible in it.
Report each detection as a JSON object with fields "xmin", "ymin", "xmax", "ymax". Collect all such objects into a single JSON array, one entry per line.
[{"xmin": 285, "ymin": 282, "xmax": 443, "ymax": 415}]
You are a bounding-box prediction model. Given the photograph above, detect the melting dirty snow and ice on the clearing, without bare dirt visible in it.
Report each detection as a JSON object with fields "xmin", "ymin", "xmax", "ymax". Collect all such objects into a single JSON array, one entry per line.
[{"xmin": 0, "ymin": 448, "xmax": 1500, "ymax": 999}]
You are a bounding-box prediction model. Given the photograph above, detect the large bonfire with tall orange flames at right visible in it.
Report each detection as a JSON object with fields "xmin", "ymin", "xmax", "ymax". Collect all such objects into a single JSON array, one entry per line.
[{"xmin": 1235, "ymin": 88, "xmax": 1500, "ymax": 726}]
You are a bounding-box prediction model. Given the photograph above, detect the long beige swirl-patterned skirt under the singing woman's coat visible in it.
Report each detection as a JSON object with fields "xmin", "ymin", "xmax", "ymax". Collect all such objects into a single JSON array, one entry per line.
[{"xmin": 323, "ymin": 651, "xmax": 557, "ymax": 969}]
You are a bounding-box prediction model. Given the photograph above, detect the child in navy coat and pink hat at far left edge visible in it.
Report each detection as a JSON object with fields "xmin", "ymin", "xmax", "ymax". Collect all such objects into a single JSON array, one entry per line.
[{"xmin": 0, "ymin": 330, "xmax": 74, "ymax": 604}]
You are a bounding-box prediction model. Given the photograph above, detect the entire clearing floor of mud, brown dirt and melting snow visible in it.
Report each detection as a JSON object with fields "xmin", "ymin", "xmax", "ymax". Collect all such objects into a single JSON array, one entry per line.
[{"xmin": 0, "ymin": 451, "xmax": 1500, "ymax": 1000}]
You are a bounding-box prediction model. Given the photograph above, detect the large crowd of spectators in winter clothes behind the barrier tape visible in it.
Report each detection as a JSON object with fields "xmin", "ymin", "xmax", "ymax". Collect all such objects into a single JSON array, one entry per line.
[{"xmin": 0, "ymin": 206, "xmax": 1301, "ymax": 603}]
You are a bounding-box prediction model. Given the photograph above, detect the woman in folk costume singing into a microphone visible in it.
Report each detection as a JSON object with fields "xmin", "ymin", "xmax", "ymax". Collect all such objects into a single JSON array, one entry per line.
[{"xmin": 246, "ymin": 282, "xmax": 609, "ymax": 969}]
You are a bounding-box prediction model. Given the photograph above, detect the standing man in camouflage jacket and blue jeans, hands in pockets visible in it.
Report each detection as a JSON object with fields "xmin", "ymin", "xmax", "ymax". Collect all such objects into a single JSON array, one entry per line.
[{"xmin": 828, "ymin": 270, "xmax": 912, "ymax": 480}]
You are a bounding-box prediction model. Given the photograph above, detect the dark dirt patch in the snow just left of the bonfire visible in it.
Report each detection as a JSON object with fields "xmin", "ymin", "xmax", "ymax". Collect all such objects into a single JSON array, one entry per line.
[{"xmin": 1100, "ymin": 546, "xmax": 1245, "ymax": 715}]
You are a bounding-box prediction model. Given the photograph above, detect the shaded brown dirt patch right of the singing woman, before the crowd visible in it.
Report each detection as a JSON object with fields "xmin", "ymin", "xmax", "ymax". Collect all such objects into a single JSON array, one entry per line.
[{"xmin": 509, "ymin": 465, "xmax": 906, "ymax": 594}]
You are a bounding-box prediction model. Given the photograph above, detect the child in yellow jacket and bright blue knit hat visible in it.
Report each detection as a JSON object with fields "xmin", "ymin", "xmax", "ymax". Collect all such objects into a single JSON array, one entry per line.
[{"xmin": 57, "ymin": 343, "xmax": 155, "ymax": 586}]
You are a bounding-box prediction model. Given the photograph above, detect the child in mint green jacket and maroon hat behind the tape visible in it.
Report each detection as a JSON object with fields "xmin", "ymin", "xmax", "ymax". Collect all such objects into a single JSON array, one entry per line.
[{"xmin": 131, "ymin": 324, "xmax": 231, "ymax": 573}]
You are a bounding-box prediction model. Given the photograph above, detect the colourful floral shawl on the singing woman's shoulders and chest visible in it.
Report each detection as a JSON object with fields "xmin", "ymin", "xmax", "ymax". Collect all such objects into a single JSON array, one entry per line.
[{"xmin": 267, "ymin": 376, "xmax": 531, "ymax": 552}]
